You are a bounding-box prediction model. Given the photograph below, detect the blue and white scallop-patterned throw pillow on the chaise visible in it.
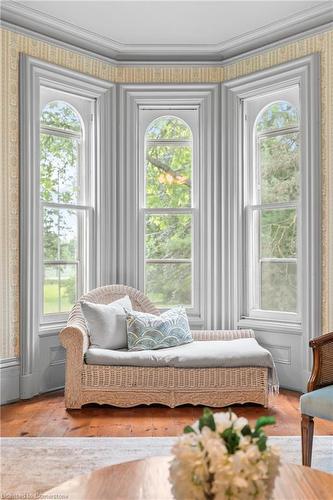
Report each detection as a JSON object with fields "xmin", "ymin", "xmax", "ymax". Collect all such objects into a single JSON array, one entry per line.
[{"xmin": 126, "ymin": 306, "xmax": 193, "ymax": 351}]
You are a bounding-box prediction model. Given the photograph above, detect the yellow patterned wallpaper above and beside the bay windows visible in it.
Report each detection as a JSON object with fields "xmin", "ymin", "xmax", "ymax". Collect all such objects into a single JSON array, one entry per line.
[{"xmin": 0, "ymin": 29, "xmax": 333, "ymax": 358}]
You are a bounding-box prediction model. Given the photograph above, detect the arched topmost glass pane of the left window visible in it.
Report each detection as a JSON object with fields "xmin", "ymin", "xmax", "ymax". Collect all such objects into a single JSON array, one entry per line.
[{"xmin": 40, "ymin": 101, "xmax": 81, "ymax": 132}]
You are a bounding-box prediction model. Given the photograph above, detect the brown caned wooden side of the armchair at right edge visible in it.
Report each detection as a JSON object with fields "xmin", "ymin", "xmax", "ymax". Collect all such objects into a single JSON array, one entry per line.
[{"xmin": 308, "ymin": 332, "xmax": 333, "ymax": 392}]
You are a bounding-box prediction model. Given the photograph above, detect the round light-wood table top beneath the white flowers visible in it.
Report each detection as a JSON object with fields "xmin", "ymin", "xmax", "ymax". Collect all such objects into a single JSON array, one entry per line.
[{"xmin": 43, "ymin": 457, "xmax": 333, "ymax": 500}]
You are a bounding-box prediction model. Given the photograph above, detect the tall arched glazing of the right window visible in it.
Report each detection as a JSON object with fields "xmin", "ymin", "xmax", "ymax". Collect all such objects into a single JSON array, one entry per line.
[{"xmin": 249, "ymin": 96, "xmax": 300, "ymax": 313}]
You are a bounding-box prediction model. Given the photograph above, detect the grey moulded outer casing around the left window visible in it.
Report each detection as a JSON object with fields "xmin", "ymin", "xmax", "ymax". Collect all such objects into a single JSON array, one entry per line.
[{"xmin": 20, "ymin": 54, "xmax": 116, "ymax": 398}]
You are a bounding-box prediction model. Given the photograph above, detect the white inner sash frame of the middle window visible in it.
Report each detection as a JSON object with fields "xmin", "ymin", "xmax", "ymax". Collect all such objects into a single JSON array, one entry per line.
[{"xmin": 138, "ymin": 106, "xmax": 200, "ymax": 315}]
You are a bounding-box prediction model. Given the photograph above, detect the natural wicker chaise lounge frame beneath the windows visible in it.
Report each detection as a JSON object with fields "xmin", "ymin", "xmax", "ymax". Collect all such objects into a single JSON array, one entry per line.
[{"xmin": 60, "ymin": 285, "xmax": 269, "ymax": 409}]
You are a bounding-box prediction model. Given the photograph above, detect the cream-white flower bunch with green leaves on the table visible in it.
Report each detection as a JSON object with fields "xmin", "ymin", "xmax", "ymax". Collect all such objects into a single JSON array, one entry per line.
[{"xmin": 170, "ymin": 409, "xmax": 280, "ymax": 500}]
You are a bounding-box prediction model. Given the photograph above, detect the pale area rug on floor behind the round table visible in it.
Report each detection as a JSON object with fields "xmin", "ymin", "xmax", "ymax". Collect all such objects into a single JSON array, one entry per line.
[{"xmin": 0, "ymin": 436, "xmax": 333, "ymax": 498}]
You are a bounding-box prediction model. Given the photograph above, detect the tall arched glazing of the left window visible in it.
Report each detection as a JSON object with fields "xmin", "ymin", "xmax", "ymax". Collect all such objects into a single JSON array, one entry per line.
[{"xmin": 40, "ymin": 95, "xmax": 88, "ymax": 317}]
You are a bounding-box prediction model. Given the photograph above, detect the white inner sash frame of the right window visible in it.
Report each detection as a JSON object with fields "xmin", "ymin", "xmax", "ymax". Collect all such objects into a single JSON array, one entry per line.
[{"xmin": 243, "ymin": 85, "xmax": 304, "ymax": 324}]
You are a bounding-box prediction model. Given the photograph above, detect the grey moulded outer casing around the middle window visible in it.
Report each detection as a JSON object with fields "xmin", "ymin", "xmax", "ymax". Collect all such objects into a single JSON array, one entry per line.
[{"xmin": 115, "ymin": 84, "xmax": 218, "ymax": 329}]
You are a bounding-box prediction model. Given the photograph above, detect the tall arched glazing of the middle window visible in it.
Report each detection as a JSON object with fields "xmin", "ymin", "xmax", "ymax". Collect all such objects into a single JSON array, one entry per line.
[{"xmin": 144, "ymin": 115, "xmax": 194, "ymax": 308}]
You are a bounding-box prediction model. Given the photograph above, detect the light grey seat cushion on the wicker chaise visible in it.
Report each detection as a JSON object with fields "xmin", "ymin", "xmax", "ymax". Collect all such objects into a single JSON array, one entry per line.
[{"xmin": 85, "ymin": 338, "xmax": 274, "ymax": 368}]
